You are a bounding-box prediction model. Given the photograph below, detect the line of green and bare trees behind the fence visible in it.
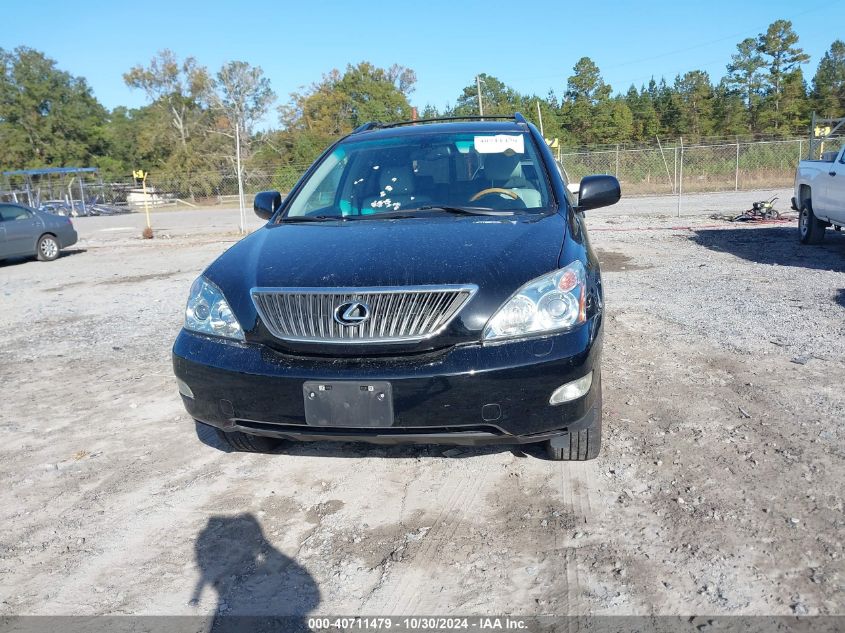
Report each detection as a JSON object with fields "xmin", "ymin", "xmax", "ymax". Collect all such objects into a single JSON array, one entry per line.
[{"xmin": 0, "ymin": 20, "xmax": 845, "ymax": 193}]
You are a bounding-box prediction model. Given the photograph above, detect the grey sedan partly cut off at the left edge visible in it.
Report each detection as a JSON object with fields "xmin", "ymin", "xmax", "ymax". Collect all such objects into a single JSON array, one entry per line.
[{"xmin": 0, "ymin": 202, "xmax": 77, "ymax": 262}]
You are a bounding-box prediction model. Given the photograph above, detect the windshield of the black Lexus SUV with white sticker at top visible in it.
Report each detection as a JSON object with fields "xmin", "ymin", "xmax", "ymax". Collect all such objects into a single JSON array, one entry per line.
[{"xmin": 285, "ymin": 127, "xmax": 551, "ymax": 219}]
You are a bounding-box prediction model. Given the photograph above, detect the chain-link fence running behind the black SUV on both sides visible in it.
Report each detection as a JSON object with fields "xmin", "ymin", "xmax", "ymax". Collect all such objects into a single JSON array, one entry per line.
[{"xmin": 8, "ymin": 138, "xmax": 843, "ymax": 209}]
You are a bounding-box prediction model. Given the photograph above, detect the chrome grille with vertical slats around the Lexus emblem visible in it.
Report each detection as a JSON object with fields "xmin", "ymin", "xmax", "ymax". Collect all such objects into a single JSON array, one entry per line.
[{"xmin": 252, "ymin": 285, "xmax": 478, "ymax": 343}]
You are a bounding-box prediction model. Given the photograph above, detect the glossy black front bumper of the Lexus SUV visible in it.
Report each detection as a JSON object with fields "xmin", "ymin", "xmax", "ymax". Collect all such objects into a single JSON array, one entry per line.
[{"xmin": 173, "ymin": 316, "xmax": 601, "ymax": 444}]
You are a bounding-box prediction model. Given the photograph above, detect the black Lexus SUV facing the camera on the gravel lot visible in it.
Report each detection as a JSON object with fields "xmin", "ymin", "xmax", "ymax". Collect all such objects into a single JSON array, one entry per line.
[{"xmin": 173, "ymin": 114, "xmax": 620, "ymax": 460}]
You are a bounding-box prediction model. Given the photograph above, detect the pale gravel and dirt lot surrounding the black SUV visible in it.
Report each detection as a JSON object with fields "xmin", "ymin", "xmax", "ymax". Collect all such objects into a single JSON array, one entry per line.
[{"xmin": 0, "ymin": 196, "xmax": 845, "ymax": 615}]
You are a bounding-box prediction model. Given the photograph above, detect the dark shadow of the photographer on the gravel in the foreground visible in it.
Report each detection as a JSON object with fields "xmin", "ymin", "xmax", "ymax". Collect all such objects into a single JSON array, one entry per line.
[{"xmin": 191, "ymin": 513, "xmax": 320, "ymax": 633}]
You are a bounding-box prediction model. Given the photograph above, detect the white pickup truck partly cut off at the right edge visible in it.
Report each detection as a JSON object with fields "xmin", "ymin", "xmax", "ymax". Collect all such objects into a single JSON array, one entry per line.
[{"xmin": 792, "ymin": 144, "xmax": 845, "ymax": 244}]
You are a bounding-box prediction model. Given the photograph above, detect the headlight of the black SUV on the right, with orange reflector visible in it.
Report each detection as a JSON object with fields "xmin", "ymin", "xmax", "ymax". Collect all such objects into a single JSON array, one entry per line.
[{"xmin": 482, "ymin": 260, "xmax": 587, "ymax": 341}]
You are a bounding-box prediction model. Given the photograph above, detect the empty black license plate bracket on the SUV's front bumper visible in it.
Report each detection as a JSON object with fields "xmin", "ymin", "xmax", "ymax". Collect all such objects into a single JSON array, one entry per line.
[{"xmin": 302, "ymin": 380, "xmax": 393, "ymax": 428}]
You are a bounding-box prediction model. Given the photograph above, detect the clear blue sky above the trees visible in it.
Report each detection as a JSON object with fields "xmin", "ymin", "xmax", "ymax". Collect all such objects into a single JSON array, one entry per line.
[{"xmin": 0, "ymin": 0, "xmax": 845, "ymax": 125}]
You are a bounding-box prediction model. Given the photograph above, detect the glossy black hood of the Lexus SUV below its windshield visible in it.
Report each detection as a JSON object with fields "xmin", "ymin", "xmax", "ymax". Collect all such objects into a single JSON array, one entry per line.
[{"xmin": 205, "ymin": 214, "xmax": 566, "ymax": 350}]
